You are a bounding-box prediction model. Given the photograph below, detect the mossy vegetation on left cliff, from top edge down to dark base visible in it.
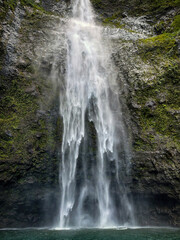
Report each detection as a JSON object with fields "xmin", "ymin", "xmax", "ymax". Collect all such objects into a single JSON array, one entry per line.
[{"xmin": 0, "ymin": 0, "xmax": 60, "ymax": 185}]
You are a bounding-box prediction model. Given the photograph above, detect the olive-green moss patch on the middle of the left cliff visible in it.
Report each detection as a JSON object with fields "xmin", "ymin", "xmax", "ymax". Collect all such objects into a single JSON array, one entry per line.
[{"xmin": 0, "ymin": 72, "xmax": 57, "ymax": 182}]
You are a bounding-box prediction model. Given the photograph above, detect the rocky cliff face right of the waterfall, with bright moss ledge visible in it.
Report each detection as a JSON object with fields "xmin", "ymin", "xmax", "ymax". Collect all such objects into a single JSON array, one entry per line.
[{"xmin": 99, "ymin": 1, "xmax": 180, "ymax": 226}]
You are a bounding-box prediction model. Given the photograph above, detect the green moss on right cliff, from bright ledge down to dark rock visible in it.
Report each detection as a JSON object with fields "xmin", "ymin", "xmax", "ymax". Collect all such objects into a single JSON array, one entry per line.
[{"xmin": 134, "ymin": 24, "xmax": 180, "ymax": 151}]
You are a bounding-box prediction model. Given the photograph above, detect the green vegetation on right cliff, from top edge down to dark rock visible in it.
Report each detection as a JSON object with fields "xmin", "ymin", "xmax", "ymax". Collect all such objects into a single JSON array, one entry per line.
[{"xmin": 92, "ymin": 0, "xmax": 180, "ymax": 151}]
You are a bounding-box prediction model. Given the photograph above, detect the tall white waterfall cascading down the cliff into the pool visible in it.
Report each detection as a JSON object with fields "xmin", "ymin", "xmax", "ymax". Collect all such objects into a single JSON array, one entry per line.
[{"xmin": 58, "ymin": 0, "xmax": 133, "ymax": 228}]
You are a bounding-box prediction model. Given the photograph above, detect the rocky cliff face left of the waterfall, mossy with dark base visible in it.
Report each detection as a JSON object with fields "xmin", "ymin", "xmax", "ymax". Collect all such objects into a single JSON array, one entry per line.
[{"xmin": 0, "ymin": 1, "xmax": 65, "ymax": 227}]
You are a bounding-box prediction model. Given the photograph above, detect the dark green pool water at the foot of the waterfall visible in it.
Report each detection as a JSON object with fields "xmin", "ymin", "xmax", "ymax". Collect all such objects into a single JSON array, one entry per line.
[{"xmin": 0, "ymin": 229, "xmax": 180, "ymax": 240}]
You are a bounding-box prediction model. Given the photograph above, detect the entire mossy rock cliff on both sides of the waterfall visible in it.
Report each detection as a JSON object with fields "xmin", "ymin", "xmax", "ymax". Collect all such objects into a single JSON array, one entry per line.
[{"xmin": 0, "ymin": 0, "xmax": 180, "ymax": 227}]
